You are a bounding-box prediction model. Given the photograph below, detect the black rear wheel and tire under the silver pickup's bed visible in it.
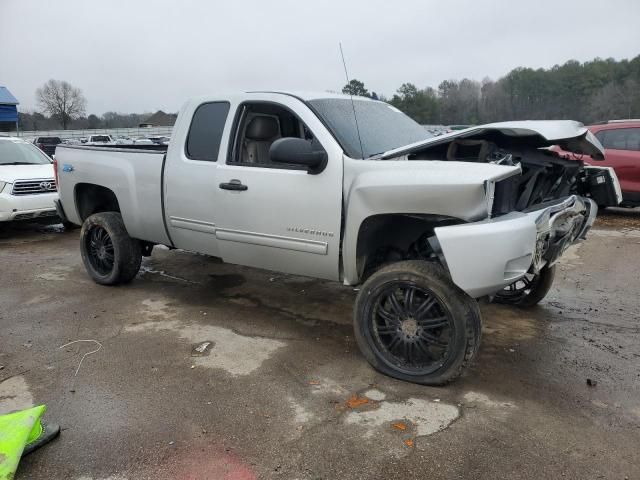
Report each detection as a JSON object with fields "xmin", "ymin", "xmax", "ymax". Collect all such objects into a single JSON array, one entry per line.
[{"xmin": 80, "ymin": 212, "xmax": 142, "ymax": 285}]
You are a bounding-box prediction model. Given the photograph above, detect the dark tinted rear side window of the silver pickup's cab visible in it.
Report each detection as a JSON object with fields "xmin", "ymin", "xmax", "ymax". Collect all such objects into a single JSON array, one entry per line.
[{"xmin": 186, "ymin": 102, "xmax": 229, "ymax": 162}]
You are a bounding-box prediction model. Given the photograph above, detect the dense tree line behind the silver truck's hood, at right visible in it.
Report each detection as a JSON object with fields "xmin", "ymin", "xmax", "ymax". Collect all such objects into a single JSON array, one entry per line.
[{"xmin": 342, "ymin": 55, "xmax": 640, "ymax": 125}]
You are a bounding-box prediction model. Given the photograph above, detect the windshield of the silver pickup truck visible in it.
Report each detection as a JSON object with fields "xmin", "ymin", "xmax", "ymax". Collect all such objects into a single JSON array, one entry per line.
[{"xmin": 308, "ymin": 98, "xmax": 433, "ymax": 158}]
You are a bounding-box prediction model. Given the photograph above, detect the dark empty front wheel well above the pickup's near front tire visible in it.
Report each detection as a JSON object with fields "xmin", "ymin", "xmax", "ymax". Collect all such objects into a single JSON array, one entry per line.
[{"xmin": 356, "ymin": 213, "xmax": 464, "ymax": 280}]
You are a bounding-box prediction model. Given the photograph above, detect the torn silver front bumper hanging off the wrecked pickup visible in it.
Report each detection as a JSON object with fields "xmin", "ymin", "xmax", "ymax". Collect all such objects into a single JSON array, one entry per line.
[{"xmin": 435, "ymin": 195, "xmax": 598, "ymax": 298}]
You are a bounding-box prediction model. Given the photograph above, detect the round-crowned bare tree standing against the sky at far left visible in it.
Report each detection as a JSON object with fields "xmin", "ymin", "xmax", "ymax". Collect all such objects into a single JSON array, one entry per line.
[{"xmin": 36, "ymin": 80, "xmax": 87, "ymax": 130}]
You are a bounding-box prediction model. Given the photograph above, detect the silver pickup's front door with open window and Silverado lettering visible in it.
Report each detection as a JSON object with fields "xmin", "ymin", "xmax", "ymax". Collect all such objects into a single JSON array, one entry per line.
[{"xmin": 216, "ymin": 96, "xmax": 343, "ymax": 280}]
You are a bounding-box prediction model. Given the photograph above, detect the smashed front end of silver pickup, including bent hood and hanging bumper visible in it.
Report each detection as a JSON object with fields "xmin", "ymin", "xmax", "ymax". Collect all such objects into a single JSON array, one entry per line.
[{"xmin": 382, "ymin": 121, "xmax": 621, "ymax": 297}]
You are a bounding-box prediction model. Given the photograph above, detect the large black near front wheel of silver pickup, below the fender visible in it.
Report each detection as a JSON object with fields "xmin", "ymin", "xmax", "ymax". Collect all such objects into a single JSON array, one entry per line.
[{"xmin": 354, "ymin": 260, "xmax": 482, "ymax": 385}]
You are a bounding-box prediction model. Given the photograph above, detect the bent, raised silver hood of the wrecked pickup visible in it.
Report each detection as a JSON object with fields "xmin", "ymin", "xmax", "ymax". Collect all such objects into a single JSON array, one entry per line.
[{"xmin": 380, "ymin": 120, "xmax": 604, "ymax": 160}]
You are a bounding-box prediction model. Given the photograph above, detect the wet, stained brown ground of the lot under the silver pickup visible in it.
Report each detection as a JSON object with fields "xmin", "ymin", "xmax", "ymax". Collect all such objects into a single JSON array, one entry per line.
[{"xmin": 0, "ymin": 210, "xmax": 640, "ymax": 480}]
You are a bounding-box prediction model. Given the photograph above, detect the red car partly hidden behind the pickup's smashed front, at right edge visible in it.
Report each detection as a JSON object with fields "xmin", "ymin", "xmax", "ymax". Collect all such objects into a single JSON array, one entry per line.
[{"xmin": 559, "ymin": 120, "xmax": 640, "ymax": 207}]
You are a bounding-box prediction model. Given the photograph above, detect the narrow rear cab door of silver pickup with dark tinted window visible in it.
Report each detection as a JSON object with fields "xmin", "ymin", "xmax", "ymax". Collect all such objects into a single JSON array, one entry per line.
[{"xmin": 162, "ymin": 102, "xmax": 230, "ymax": 256}]
